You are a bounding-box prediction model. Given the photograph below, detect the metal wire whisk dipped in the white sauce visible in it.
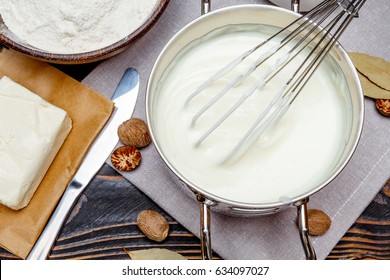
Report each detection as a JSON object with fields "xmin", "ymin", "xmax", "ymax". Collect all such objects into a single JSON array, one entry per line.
[{"xmin": 185, "ymin": 0, "xmax": 366, "ymax": 162}]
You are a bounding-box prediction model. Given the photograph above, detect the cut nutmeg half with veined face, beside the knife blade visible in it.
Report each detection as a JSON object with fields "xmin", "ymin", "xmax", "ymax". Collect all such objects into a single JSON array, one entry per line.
[{"xmin": 111, "ymin": 146, "xmax": 141, "ymax": 171}]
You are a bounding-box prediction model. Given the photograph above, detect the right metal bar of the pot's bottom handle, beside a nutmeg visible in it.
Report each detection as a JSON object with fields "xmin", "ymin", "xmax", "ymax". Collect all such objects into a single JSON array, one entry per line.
[{"xmin": 296, "ymin": 198, "xmax": 317, "ymax": 260}]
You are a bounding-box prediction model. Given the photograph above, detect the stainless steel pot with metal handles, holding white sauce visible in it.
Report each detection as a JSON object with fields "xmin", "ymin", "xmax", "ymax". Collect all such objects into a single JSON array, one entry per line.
[{"xmin": 146, "ymin": 1, "xmax": 364, "ymax": 259}]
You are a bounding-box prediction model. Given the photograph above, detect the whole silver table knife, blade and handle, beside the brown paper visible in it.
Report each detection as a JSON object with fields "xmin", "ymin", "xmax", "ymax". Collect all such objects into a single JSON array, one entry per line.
[{"xmin": 26, "ymin": 68, "xmax": 139, "ymax": 260}]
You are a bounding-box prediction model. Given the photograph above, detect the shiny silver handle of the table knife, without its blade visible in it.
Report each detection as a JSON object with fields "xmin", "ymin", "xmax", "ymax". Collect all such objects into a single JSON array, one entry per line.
[{"xmin": 26, "ymin": 180, "xmax": 80, "ymax": 260}]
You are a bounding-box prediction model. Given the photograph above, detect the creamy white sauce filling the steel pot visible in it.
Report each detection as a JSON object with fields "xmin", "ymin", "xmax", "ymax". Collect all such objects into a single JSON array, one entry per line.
[{"xmin": 153, "ymin": 26, "xmax": 349, "ymax": 203}]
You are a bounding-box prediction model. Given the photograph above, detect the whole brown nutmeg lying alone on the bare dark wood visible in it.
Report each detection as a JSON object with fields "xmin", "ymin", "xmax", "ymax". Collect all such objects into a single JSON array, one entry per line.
[{"xmin": 137, "ymin": 210, "xmax": 169, "ymax": 242}]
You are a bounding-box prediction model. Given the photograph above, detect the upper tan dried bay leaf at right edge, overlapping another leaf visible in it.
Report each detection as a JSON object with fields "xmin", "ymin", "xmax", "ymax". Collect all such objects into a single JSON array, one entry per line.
[{"xmin": 348, "ymin": 52, "xmax": 390, "ymax": 91}]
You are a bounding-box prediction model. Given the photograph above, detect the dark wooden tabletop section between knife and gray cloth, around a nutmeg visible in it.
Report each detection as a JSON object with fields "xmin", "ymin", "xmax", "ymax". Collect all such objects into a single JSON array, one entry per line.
[{"xmin": 50, "ymin": 165, "xmax": 209, "ymax": 259}]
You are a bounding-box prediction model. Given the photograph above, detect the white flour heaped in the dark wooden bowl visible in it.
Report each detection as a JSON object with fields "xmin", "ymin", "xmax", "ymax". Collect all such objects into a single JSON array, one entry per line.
[{"xmin": 0, "ymin": 0, "xmax": 158, "ymax": 53}]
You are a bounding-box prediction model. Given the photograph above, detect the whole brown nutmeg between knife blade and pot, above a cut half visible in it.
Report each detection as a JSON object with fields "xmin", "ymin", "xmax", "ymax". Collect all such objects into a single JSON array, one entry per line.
[{"xmin": 118, "ymin": 118, "xmax": 151, "ymax": 148}]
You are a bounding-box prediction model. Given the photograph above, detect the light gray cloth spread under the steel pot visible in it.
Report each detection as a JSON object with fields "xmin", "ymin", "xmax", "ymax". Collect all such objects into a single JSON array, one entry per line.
[{"xmin": 83, "ymin": 0, "xmax": 390, "ymax": 259}]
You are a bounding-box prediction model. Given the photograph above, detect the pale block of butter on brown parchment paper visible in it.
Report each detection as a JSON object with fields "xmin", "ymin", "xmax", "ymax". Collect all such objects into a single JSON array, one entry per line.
[{"xmin": 0, "ymin": 76, "xmax": 72, "ymax": 210}]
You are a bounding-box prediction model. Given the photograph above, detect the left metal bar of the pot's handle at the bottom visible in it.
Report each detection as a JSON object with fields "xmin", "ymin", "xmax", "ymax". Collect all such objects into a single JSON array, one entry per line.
[{"xmin": 196, "ymin": 194, "xmax": 215, "ymax": 260}]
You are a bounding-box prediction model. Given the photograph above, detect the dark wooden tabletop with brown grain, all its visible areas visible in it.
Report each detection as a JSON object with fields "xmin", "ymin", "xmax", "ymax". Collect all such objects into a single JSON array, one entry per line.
[{"xmin": 0, "ymin": 63, "xmax": 390, "ymax": 260}]
